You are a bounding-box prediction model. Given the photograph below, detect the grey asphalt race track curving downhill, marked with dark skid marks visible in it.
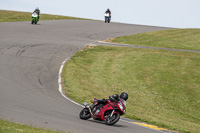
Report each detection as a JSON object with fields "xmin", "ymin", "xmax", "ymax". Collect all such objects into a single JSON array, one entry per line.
[{"xmin": 0, "ymin": 20, "xmax": 166, "ymax": 133}]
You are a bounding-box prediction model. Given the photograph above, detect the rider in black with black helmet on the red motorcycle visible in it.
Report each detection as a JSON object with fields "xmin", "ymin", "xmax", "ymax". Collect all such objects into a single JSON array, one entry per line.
[{"xmin": 90, "ymin": 92, "xmax": 128, "ymax": 112}]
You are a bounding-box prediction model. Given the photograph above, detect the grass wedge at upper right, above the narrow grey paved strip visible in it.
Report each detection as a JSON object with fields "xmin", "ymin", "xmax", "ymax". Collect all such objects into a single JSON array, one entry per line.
[{"xmin": 112, "ymin": 29, "xmax": 200, "ymax": 50}]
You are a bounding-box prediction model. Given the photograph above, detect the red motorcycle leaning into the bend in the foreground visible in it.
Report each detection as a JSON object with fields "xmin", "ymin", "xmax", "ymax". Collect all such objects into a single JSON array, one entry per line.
[{"xmin": 79, "ymin": 98, "xmax": 126, "ymax": 125}]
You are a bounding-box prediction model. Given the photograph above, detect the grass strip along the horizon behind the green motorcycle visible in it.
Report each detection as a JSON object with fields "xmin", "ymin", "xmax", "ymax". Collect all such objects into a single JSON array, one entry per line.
[{"xmin": 0, "ymin": 10, "xmax": 85, "ymax": 22}]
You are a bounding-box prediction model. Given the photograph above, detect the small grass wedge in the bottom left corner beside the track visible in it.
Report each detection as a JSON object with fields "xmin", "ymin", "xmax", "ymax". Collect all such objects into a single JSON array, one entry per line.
[{"xmin": 0, "ymin": 119, "xmax": 61, "ymax": 133}]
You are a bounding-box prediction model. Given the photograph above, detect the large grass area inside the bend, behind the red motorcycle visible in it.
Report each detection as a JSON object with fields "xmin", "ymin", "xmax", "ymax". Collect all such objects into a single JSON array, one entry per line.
[{"xmin": 62, "ymin": 36, "xmax": 200, "ymax": 133}]
